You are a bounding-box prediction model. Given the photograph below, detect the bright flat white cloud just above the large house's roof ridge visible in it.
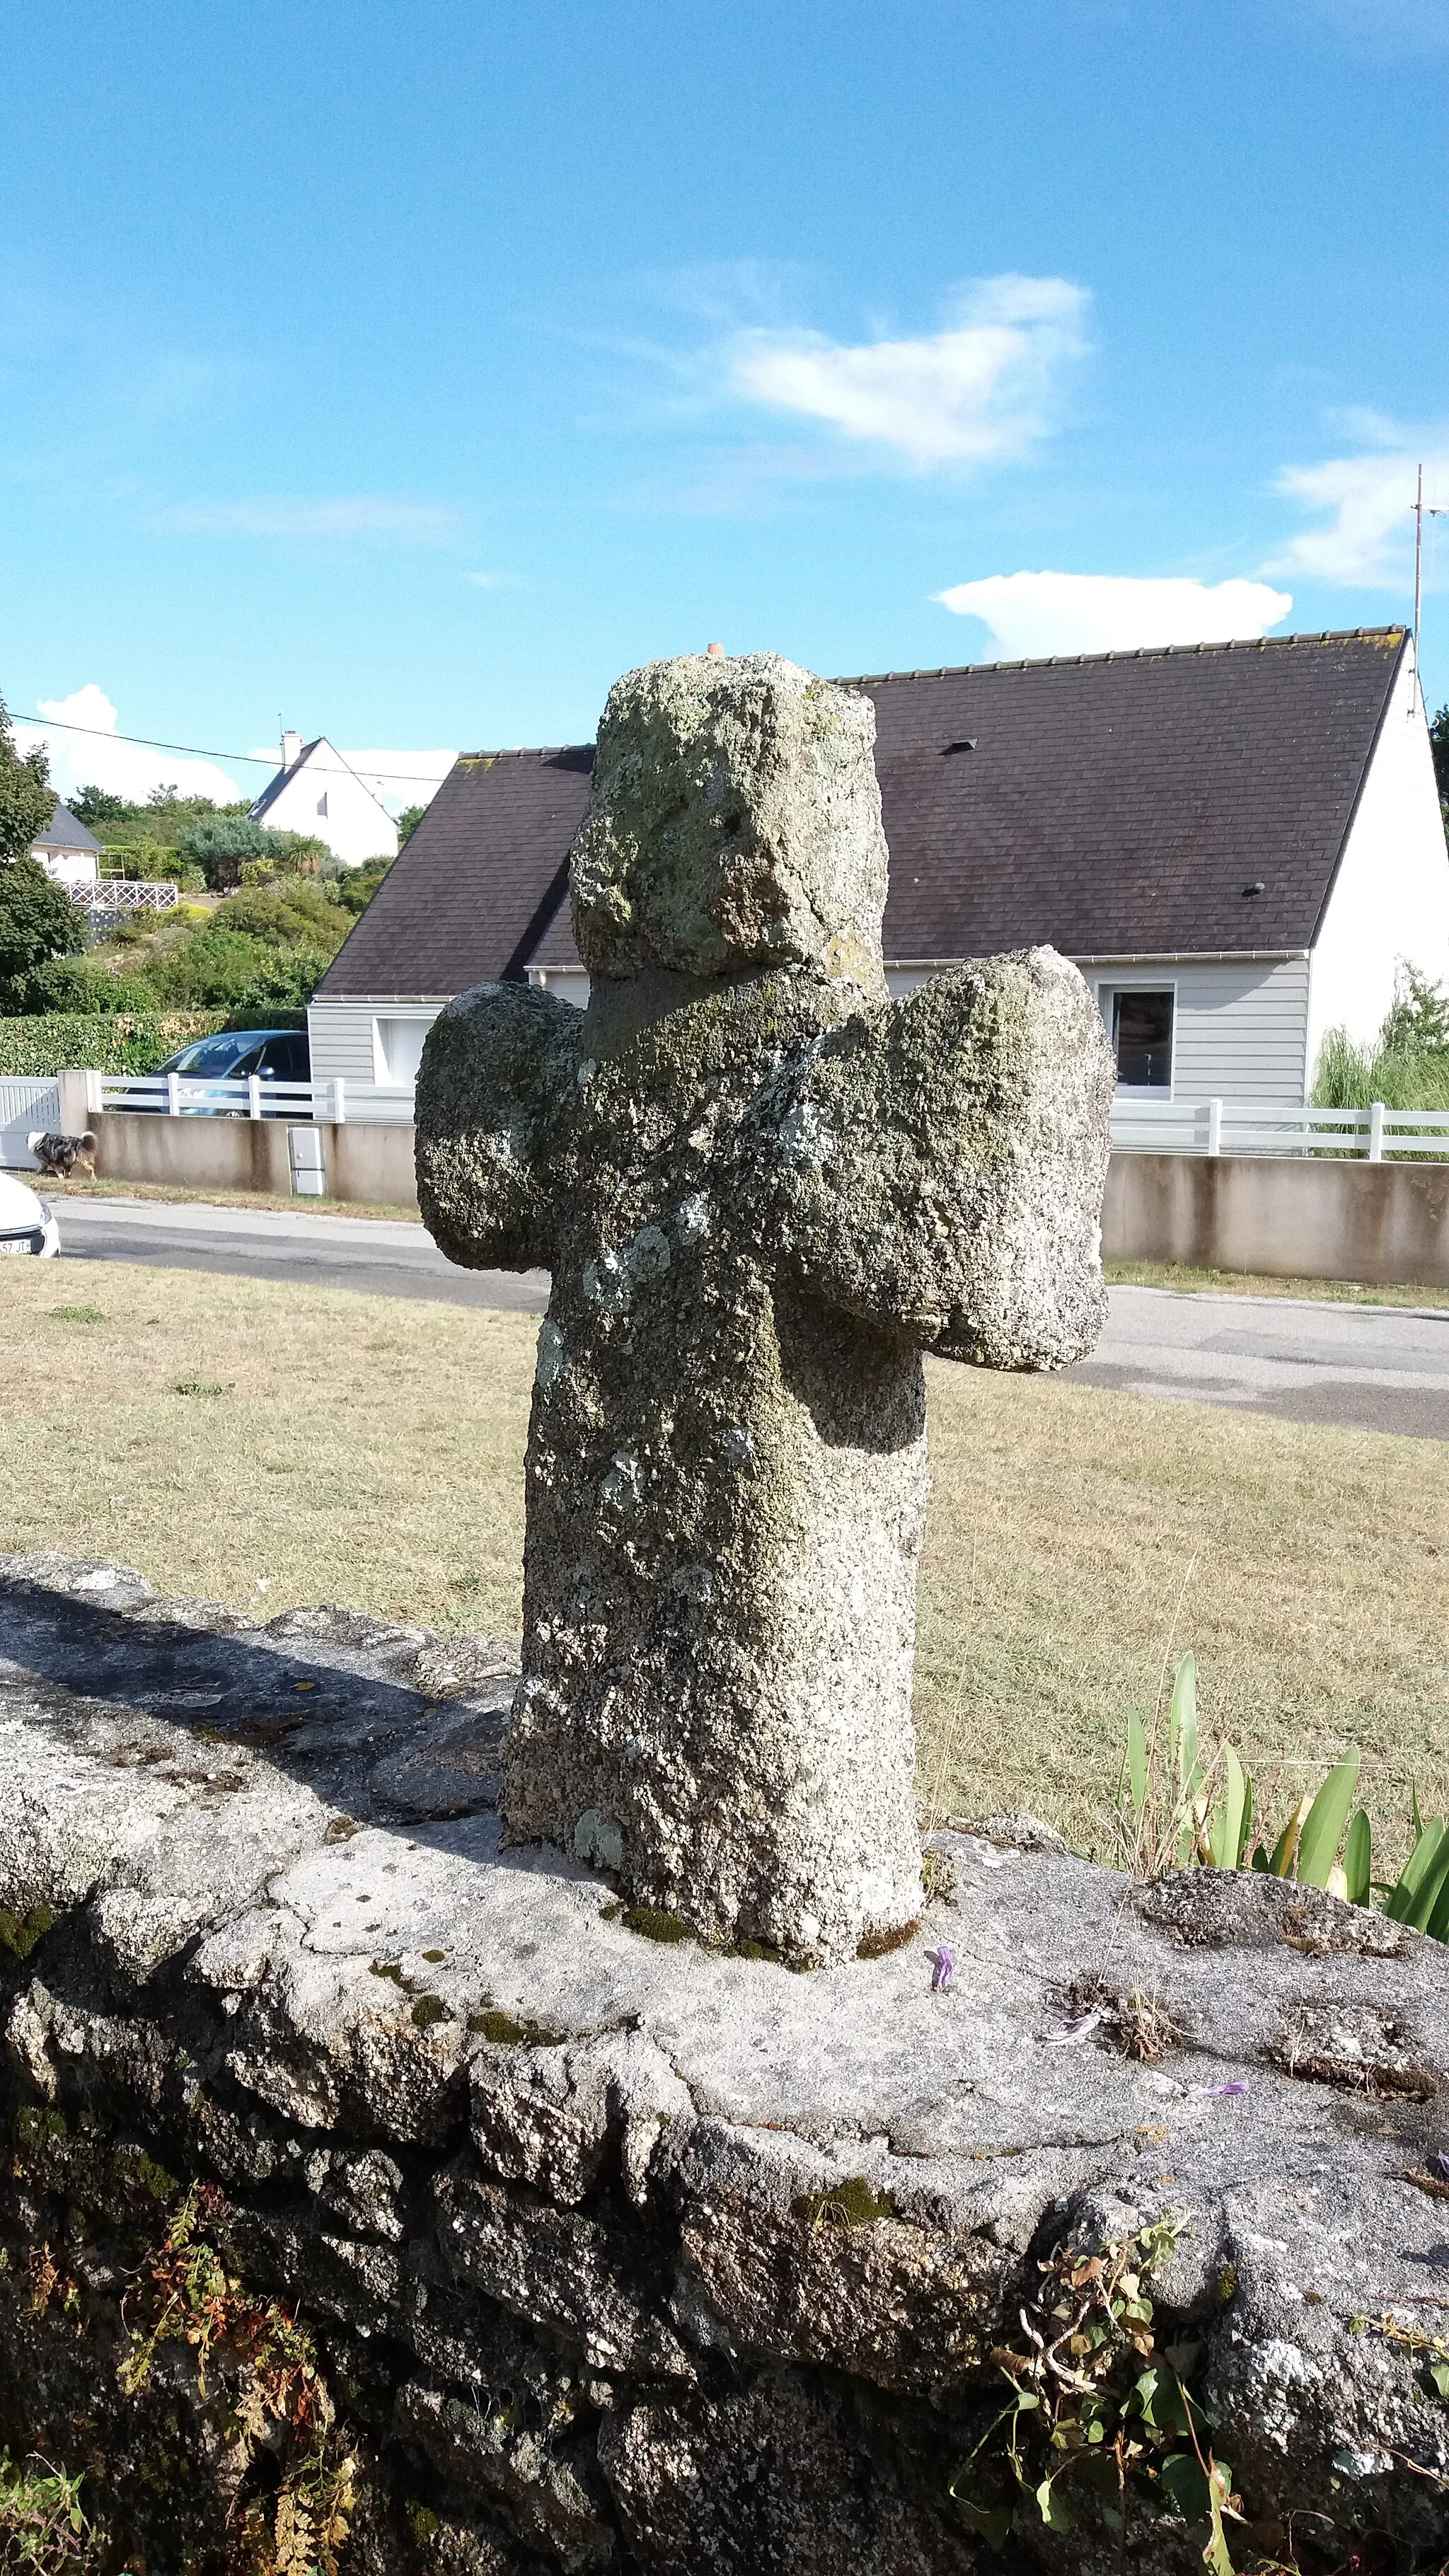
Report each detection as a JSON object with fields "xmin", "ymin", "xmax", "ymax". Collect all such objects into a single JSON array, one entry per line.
[{"xmin": 936, "ymin": 572, "xmax": 1292, "ymax": 662}]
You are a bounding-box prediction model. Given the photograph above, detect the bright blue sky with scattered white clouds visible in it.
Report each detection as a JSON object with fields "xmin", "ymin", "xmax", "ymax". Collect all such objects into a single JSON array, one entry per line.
[{"xmin": 0, "ymin": 0, "xmax": 1449, "ymax": 804}]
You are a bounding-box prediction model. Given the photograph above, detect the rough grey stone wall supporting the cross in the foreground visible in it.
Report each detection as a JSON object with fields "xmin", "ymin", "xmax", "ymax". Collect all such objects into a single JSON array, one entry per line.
[{"xmin": 0, "ymin": 1559, "xmax": 1449, "ymax": 2576}]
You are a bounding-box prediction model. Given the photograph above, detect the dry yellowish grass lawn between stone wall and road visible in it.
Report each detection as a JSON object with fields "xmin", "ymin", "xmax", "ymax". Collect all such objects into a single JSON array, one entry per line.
[{"xmin": 0, "ymin": 1262, "xmax": 1449, "ymax": 1844}]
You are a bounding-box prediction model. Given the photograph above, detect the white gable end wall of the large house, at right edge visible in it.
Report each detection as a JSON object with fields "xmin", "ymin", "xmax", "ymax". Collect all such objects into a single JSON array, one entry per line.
[{"xmin": 1307, "ymin": 654, "xmax": 1449, "ymax": 1074}]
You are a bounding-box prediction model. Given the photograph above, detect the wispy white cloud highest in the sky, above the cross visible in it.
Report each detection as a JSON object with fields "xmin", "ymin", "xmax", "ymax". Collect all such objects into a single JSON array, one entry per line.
[{"xmin": 729, "ymin": 276, "xmax": 1090, "ymax": 466}]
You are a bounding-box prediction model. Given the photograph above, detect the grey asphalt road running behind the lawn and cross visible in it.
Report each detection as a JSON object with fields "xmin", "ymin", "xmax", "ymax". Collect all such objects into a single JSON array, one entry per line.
[{"xmin": 45, "ymin": 1198, "xmax": 1449, "ymax": 1440}]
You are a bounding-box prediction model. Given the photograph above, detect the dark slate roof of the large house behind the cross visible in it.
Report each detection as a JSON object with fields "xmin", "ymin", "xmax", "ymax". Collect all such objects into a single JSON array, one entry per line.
[{"xmin": 320, "ymin": 626, "xmax": 1408, "ymax": 997}]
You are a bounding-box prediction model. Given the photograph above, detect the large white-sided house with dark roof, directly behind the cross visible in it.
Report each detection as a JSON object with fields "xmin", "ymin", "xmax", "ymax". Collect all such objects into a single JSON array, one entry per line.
[{"xmin": 309, "ymin": 626, "xmax": 1449, "ymax": 1105}]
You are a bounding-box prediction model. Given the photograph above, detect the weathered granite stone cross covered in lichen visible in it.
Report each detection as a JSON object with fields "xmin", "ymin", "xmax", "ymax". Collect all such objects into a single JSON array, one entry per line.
[{"xmin": 417, "ymin": 654, "xmax": 1114, "ymax": 1963}]
